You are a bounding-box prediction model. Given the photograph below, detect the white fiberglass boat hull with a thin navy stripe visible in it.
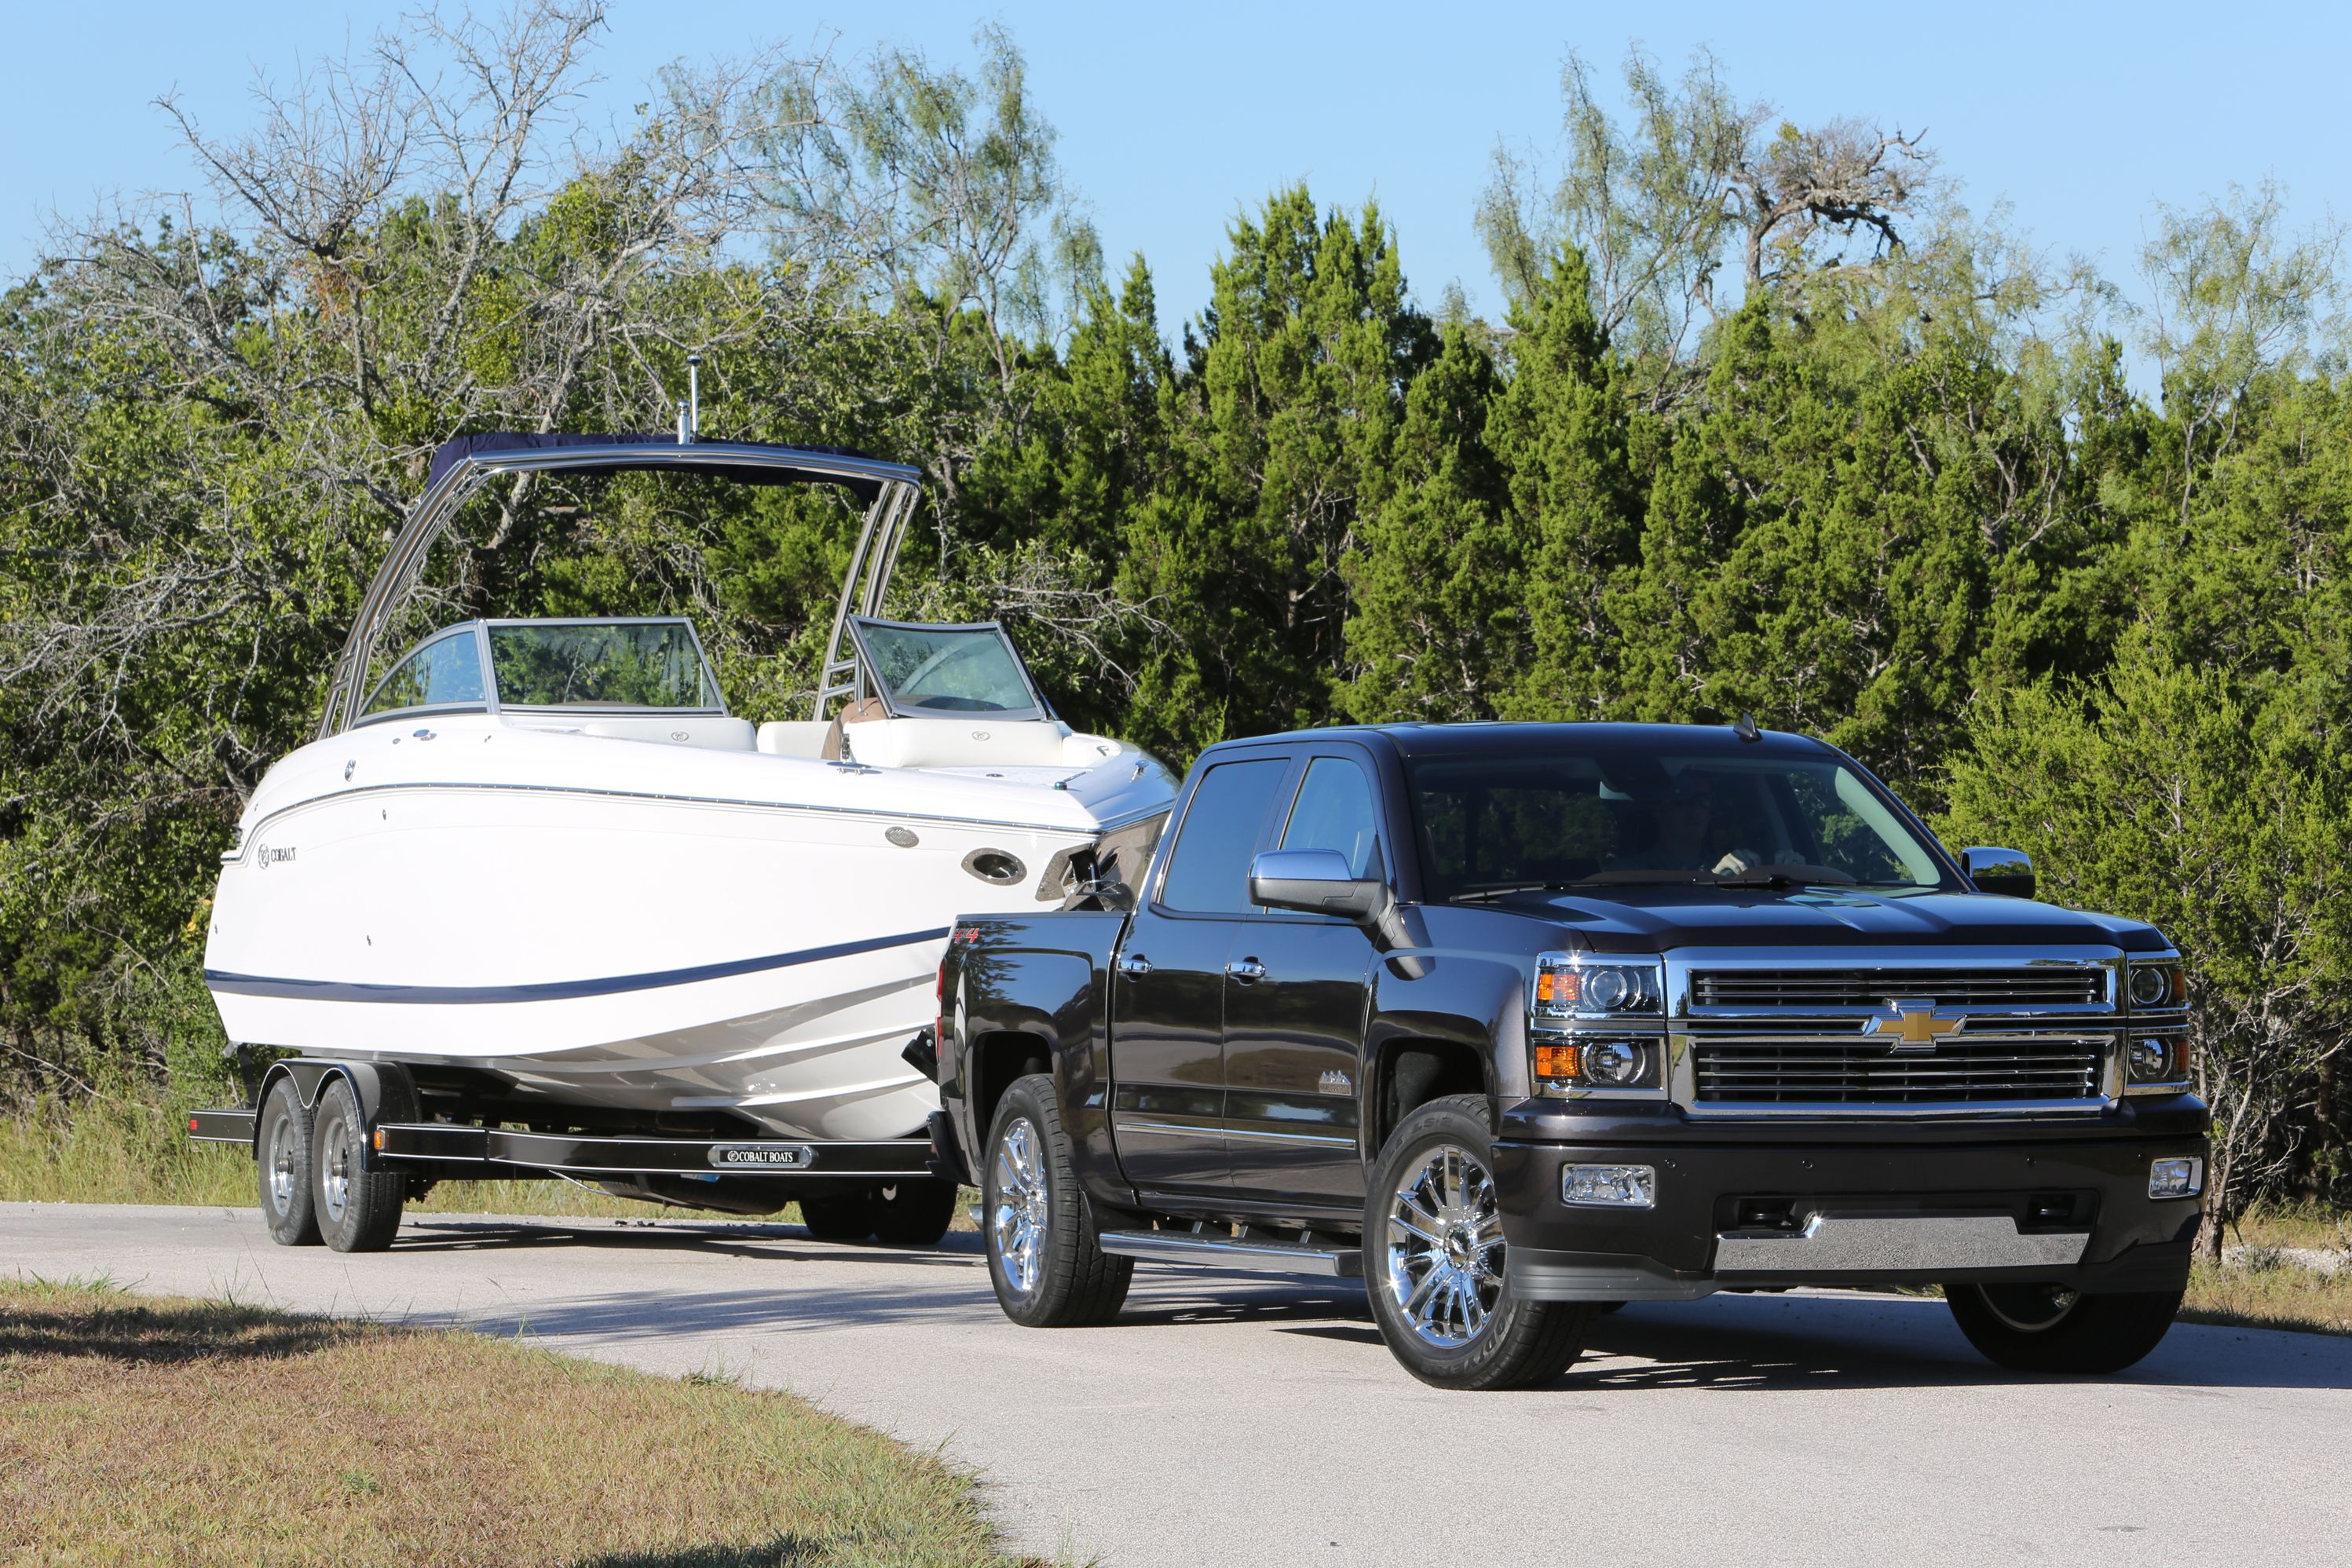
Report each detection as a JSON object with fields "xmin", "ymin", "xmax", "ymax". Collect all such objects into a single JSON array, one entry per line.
[{"xmin": 205, "ymin": 715, "xmax": 1172, "ymax": 1138}]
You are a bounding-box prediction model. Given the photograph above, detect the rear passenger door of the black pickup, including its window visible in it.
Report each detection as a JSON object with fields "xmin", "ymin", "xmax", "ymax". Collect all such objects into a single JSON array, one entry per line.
[{"xmin": 1110, "ymin": 755, "xmax": 1291, "ymax": 1192}]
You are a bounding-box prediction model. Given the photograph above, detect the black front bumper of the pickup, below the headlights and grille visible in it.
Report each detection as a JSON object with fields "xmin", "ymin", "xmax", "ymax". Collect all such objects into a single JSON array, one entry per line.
[{"xmin": 1494, "ymin": 1095, "xmax": 2206, "ymax": 1300}]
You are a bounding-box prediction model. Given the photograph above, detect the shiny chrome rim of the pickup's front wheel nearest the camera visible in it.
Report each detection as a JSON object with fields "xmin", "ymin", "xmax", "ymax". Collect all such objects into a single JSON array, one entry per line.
[{"xmin": 1388, "ymin": 1142, "xmax": 1503, "ymax": 1350}]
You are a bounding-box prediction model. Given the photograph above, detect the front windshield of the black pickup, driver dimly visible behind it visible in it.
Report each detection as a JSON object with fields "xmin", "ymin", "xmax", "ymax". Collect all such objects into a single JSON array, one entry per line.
[{"xmin": 1406, "ymin": 745, "xmax": 1943, "ymax": 901}]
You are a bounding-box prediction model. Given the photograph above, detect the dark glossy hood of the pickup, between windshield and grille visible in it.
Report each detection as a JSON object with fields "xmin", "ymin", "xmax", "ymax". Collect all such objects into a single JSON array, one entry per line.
[{"xmin": 1496, "ymin": 886, "xmax": 2171, "ymax": 952}]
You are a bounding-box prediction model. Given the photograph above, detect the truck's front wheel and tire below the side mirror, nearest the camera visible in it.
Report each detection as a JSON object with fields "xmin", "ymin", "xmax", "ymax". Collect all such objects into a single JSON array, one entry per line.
[{"xmin": 1364, "ymin": 1095, "xmax": 1600, "ymax": 1389}]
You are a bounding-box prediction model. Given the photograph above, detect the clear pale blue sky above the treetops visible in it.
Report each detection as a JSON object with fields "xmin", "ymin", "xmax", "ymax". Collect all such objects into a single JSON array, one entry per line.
[{"xmin": 0, "ymin": 0, "xmax": 2352, "ymax": 336}]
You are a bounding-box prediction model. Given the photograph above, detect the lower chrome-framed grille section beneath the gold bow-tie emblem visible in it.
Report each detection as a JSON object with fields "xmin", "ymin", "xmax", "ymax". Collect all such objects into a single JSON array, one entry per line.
[{"xmin": 1691, "ymin": 1036, "xmax": 2105, "ymax": 1107}]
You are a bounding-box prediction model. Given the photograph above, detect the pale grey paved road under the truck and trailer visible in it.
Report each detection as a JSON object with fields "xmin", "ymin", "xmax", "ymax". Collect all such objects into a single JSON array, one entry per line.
[{"xmin": 0, "ymin": 1204, "xmax": 2352, "ymax": 1568}]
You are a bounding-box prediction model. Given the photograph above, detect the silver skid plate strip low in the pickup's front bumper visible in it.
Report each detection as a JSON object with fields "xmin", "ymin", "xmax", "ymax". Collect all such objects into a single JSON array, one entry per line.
[{"xmin": 1714, "ymin": 1213, "xmax": 2091, "ymax": 1274}]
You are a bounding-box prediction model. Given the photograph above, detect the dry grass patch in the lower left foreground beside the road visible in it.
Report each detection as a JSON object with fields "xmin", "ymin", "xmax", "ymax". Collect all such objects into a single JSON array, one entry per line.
[{"xmin": 0, "ymin": 1281, "xmax": 1030, "ymax": 1568}]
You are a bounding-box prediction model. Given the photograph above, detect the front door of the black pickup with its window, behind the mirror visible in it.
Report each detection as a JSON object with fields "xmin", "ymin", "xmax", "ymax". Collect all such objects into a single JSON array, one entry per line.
[{"xmin": 1225, "ymin": 747, "xmax": 1388, "ymax": 1204}]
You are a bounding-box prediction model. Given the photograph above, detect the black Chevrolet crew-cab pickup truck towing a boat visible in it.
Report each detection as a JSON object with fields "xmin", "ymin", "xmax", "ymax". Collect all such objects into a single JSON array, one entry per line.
[{"xmin": 934, "ymin": 719, "xmax": 2208, "ymax": 1387}]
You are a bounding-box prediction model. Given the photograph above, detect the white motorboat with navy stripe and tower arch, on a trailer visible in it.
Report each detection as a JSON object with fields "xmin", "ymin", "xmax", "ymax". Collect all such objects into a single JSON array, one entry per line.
[{"xmin": 205, "ymin": 437, "xmax": 1176, "ymax": 1140}]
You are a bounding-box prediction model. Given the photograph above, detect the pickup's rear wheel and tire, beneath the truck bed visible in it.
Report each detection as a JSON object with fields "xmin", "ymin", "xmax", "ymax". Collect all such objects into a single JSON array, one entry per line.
[{"xmin": 981, "ymin": 1072, "xmax": 1136, "ymax": 1329}]
